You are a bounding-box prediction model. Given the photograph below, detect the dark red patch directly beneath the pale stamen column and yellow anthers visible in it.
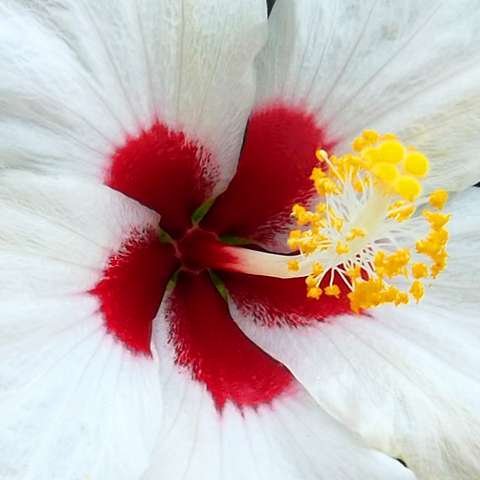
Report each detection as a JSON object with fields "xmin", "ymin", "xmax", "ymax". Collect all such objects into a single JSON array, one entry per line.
[{"xmin": 221, "ymin": 272, "xmax": 352, "ymax": 327}]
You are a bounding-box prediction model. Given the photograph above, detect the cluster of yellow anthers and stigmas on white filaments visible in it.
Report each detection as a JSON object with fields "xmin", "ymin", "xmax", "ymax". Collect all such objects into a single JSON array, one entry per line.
[{"xmin": 288, "ymin": 130, "xmax": 450, "ymax": 312}]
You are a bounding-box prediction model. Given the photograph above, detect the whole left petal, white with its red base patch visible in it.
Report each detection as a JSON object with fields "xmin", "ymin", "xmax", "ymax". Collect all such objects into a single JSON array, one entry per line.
[{"xmin": 0, "ymin": 172, "xmax": 176, "ymax": 480}]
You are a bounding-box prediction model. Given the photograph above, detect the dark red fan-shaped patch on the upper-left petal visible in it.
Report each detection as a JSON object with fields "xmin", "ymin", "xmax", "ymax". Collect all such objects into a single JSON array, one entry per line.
[{"xmin": 106, "ymin": 122, "xmax": 218, "ymax": 235}]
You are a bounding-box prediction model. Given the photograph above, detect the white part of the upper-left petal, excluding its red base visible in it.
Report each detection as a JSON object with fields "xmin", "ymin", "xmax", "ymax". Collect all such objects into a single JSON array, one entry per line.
[{"xmin": 0, "ymin": 0, "xmax": 266, "ymax": 193}]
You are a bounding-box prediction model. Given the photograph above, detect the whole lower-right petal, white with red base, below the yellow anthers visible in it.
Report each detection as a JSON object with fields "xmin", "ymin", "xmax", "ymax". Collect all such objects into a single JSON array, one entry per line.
[{"xmin": 225, "ymin": 189, "xmax": 480, "ymax": 480}]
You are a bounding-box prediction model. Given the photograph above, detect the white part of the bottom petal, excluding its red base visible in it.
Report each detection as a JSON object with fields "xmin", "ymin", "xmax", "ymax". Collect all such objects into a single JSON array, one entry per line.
[{"xmin": 142, "ymin": 287, "xmax": 414, "ymax": 480}]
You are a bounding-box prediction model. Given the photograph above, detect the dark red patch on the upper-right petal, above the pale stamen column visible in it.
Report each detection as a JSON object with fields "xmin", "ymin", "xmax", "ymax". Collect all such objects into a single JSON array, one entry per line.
[{"xmin": 202, "ymin": 104, "xmax": 334, "ymax": 245}]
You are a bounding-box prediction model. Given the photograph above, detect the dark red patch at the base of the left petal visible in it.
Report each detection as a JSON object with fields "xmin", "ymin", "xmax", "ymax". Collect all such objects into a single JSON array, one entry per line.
[{"xmin": 91, "ymin": 232, "xmax": 177, "ymax": 355}]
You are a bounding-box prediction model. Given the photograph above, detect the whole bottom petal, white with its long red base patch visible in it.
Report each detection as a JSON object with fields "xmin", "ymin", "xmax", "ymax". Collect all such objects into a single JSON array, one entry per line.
[{"xmin": 145, "ymin": 274, "xmax": 413, "ymax": 480}]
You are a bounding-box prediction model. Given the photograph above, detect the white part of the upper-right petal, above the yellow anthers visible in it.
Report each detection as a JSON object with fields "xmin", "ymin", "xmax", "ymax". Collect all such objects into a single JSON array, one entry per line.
[{"xmin": 257, "ymin": 0, "xmax": 480, "ymax": 189}]
